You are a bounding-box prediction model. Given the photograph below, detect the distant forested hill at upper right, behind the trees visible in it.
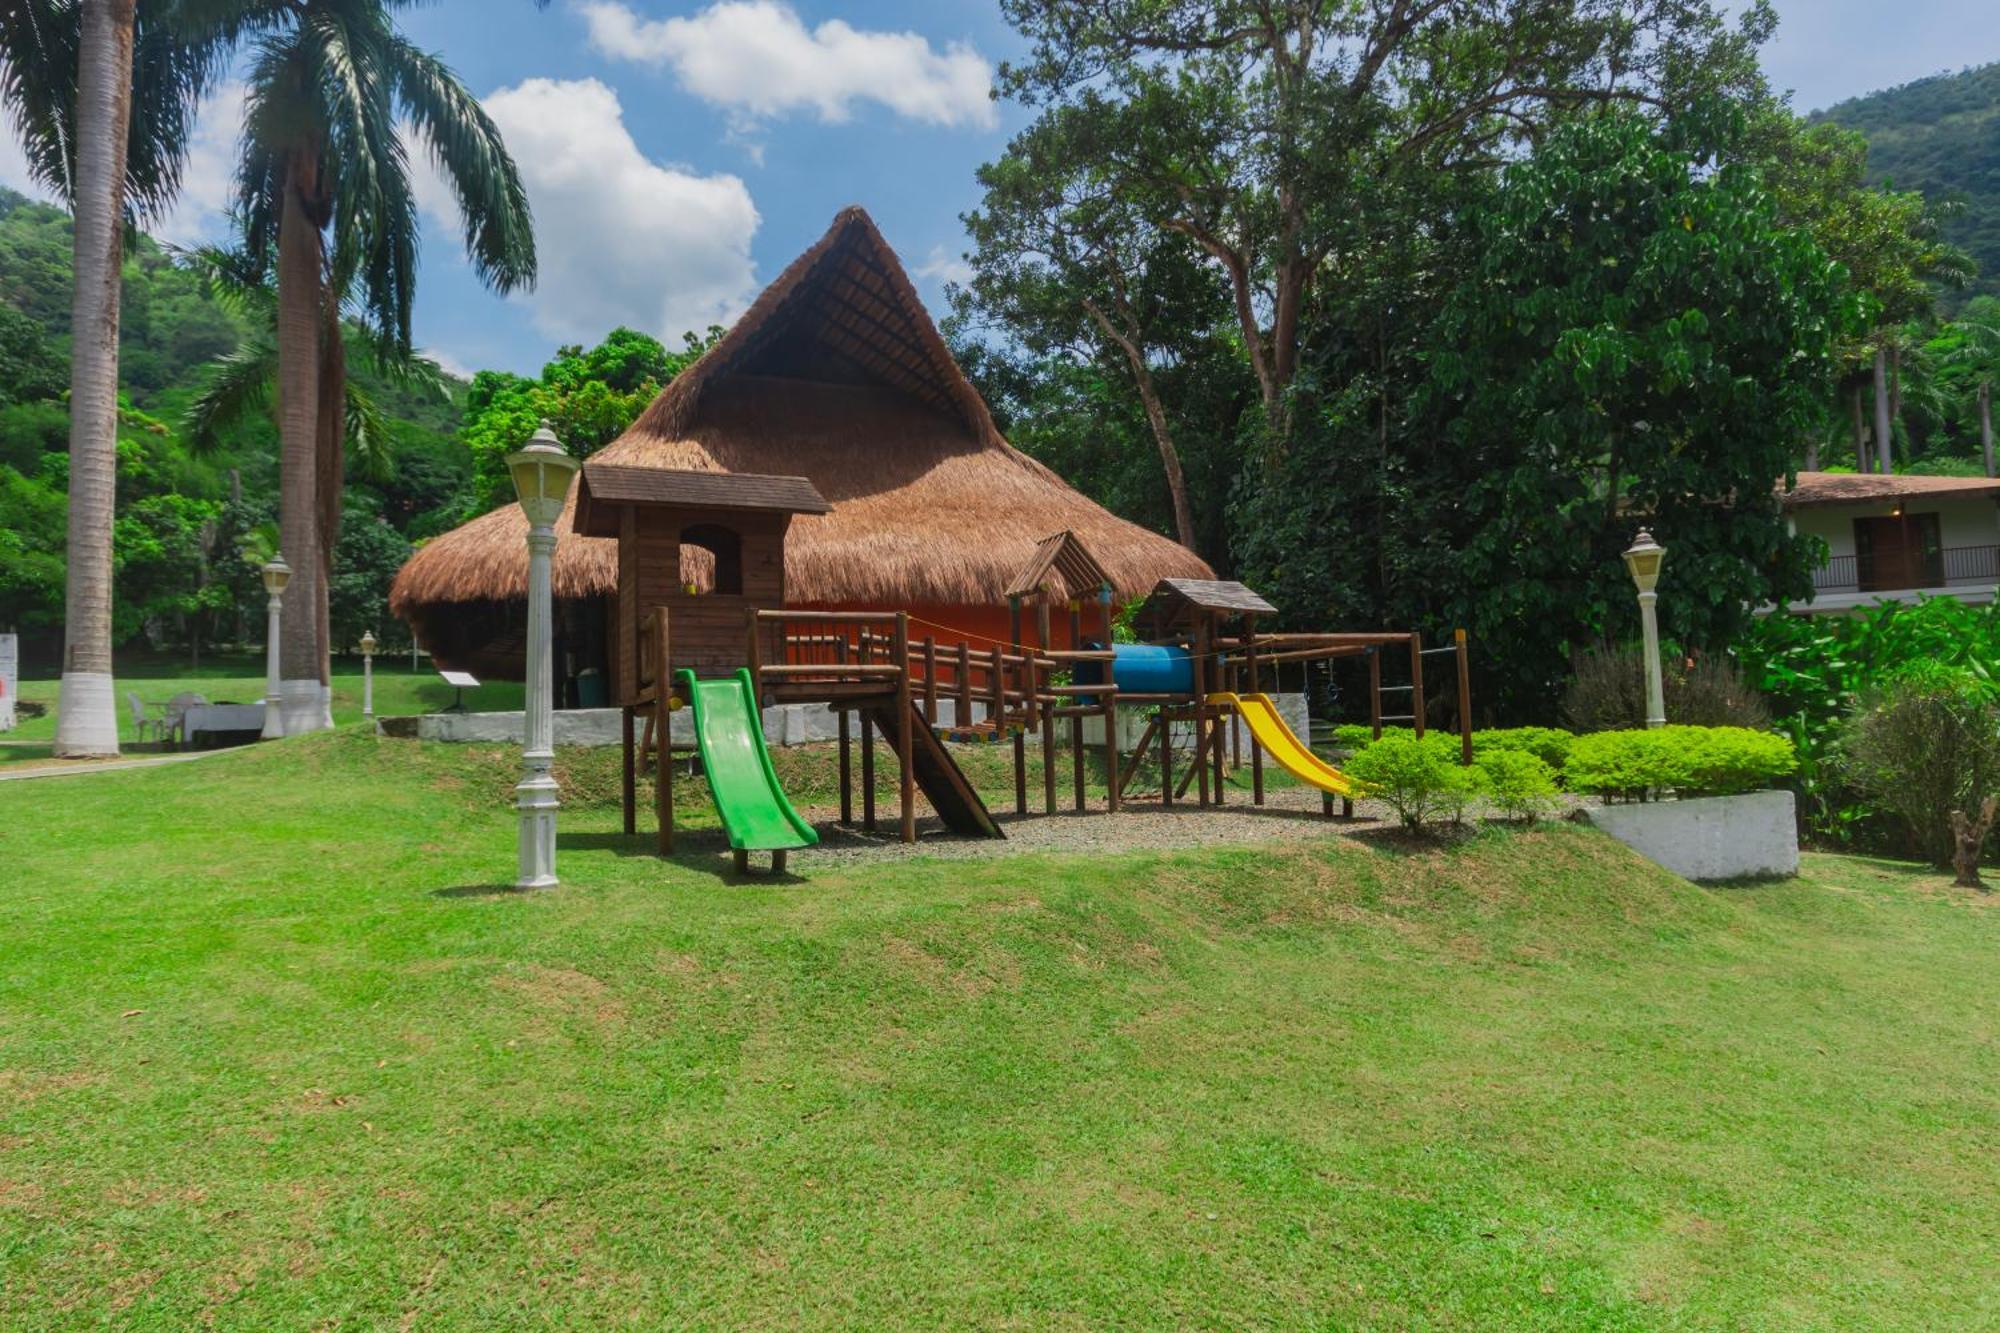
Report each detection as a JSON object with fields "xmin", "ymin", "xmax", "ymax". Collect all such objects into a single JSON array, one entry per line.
[{"xmin": 1814, "ymin": 64, "xmax": 2000, "ymax": 294}]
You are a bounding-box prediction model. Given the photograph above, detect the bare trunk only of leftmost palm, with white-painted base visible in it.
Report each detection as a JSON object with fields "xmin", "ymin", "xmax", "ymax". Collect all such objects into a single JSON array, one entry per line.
[{"xmin": 56, "ymin": 0, "xmax": 138, "ymax": 757}]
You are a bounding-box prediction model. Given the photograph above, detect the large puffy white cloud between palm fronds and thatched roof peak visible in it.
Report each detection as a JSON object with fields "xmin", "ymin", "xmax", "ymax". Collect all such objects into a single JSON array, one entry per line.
[{"xmin": 412, "ymin": 78, "xmax": 758, "ymax": 344}]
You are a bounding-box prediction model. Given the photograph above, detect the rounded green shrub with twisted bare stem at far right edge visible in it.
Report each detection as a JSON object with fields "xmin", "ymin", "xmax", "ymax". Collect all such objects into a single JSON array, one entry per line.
[{"xmin": 1844, "ymin": 664, "xmax": 2000, "ymax": 867}]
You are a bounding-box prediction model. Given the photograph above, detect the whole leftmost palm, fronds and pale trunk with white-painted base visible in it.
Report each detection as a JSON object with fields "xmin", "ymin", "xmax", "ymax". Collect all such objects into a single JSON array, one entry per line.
[{"xmin": 0, "ymin": 0, "xmax": 230, "ymax": 757}]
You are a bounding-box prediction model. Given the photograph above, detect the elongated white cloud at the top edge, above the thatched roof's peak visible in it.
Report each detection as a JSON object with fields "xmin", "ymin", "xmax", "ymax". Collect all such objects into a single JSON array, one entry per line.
[{"xmin": 578, "ymin": 0, "xmax": 998, "ymax": 130}]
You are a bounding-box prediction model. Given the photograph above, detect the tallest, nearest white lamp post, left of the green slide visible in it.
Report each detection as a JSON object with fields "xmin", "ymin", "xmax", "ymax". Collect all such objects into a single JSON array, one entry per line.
[{"xmin": 506, "ymin": 420, "xmax": 576, "ymax": 889}]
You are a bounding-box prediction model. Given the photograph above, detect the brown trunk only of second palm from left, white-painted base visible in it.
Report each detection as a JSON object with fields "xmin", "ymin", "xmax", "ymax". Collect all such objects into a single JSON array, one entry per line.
[{"xmin": 278, "ymin": 154, "xmax": 324, "ymax": 735}]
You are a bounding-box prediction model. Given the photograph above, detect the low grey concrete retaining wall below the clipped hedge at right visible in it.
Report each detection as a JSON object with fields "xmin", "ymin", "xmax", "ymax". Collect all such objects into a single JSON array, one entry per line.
[{"xmin": 1584, "ymin": 791, "xmax": 1798, "ymax": 879}]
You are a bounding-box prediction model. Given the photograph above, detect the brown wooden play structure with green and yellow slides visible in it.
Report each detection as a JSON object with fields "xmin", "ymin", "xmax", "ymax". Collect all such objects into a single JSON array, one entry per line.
[{"xmin": 576, "ymin": 462, "xmax": 1470, "ymax": 869}]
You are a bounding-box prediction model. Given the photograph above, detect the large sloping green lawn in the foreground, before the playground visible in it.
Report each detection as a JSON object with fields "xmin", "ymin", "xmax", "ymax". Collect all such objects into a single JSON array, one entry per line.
[{"xmin": 0, "ymin": 729, "xmax": 2000, "ymax": 1329}]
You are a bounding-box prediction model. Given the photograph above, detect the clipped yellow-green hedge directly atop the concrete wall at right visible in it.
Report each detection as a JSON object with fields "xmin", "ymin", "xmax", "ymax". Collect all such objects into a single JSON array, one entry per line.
[{"xmin": 1562, "ymin": 727, "xmax": 1798, "ymax": 799}]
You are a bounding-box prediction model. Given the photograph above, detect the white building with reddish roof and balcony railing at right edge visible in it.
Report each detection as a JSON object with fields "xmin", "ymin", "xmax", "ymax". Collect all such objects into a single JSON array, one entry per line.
[{"xmin": 1782, "ymin": 472, "xmax": 2000, "ymax": 612}]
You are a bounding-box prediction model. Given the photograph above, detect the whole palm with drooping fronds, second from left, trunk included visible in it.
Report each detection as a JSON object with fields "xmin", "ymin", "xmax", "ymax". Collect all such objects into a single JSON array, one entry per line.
[{"xmin": 238, "ymin": 0, "xmax": 534, "ymax": 731}]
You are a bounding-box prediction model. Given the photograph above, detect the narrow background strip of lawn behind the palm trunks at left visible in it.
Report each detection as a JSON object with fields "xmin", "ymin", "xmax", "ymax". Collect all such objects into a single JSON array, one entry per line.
[{"xmin": 0, "ymin": 656, "xmax": 522, "ymax": 765}]
